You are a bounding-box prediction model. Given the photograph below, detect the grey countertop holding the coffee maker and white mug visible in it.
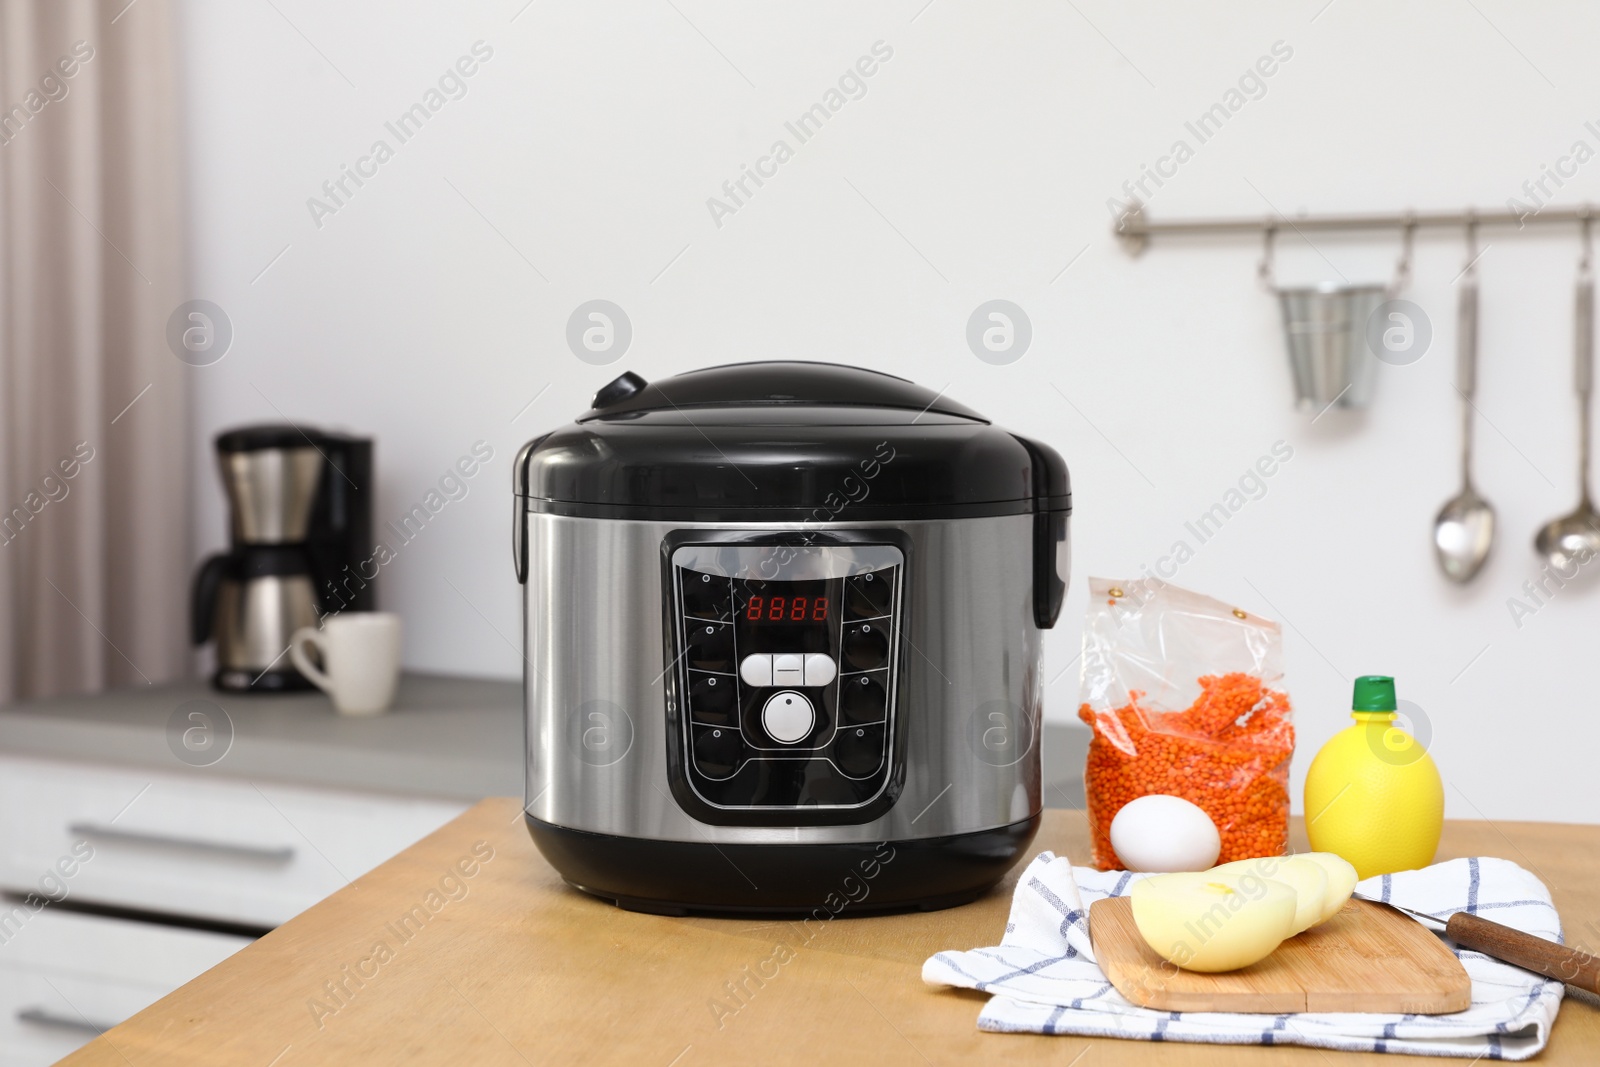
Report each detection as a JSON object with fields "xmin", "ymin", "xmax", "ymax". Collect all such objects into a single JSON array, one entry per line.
[{"xmin": 0, "ymin": 673, "xmax": 1090, "ymax": 808}]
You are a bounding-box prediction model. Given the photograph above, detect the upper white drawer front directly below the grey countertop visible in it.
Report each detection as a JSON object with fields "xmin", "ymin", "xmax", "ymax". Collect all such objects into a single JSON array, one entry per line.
[{"xmin": 0, "ymin": 757, "xmax": 466, "ymax": 928}]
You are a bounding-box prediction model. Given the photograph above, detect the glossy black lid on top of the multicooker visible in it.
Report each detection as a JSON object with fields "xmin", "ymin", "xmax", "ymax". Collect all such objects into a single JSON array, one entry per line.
[{"xmin": 514, "ymin": 362, "xmax": 1072, "ymax": 522}]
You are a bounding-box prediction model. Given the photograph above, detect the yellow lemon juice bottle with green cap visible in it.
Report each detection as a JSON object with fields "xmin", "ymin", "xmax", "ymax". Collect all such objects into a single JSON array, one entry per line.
[{"xmin": 1306, "ymin": 675, "xmax": 1445, "ymax": 878}]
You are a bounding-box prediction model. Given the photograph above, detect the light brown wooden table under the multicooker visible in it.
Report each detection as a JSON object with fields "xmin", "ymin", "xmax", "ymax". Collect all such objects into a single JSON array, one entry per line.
[{"xmin": 62, "ymin": 798, "xmax": 1600, "ymax": 1067}]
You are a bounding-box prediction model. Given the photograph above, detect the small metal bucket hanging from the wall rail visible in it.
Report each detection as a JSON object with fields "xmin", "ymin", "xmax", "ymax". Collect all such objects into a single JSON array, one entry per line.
[{"xmin": 1277, "ymin": 285, "xmax": 1390, "ymax": 413}]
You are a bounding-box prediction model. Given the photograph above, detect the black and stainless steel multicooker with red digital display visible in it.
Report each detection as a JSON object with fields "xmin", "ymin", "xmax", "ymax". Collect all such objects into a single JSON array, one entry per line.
[{"xmin": 512, "ymin": 362, "xmax": 1072, "ymax": 913}]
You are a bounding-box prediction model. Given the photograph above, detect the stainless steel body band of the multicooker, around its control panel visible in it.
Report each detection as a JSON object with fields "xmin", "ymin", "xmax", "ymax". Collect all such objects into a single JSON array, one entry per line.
[{"xmin": 523, "ymin": 512, "xmax": 1067, "ymax": 845}]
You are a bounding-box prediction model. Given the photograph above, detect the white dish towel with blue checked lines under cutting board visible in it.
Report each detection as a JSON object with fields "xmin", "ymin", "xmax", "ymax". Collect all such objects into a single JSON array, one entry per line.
[{"xmin": 922, "ymin": 853, "xmax": 1565, "ymax": 1059}]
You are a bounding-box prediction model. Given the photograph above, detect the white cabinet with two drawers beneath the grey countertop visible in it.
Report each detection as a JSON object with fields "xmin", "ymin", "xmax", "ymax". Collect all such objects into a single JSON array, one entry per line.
[{"xmin": 0, "ymin": 755, "xmax": 467, "ymax": 1067}]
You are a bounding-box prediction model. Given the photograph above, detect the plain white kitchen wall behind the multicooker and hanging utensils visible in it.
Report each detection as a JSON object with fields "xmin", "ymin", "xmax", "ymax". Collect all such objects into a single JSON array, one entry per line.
[{"xmin": 184, "ymin": 0, "xmax": 1600, "ymax": 837}]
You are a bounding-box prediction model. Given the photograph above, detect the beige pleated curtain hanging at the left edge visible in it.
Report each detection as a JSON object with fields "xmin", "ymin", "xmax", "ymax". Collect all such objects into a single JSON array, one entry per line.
[{"xmin": 0, "ymin": 0, "xmax": 192, "ymax": 701}]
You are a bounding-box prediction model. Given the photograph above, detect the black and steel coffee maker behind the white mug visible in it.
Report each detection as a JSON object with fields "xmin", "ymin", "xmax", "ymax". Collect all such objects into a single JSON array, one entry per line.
[{"xmin": 190, "ymin": 426, "xmax": 376, "ymax": 693}]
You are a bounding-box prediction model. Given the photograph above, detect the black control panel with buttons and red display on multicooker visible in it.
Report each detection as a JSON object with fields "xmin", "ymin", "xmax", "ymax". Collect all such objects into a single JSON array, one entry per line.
[{"xmin": 667, "ymin": 542, "xmax": 906, "ymax": 822}]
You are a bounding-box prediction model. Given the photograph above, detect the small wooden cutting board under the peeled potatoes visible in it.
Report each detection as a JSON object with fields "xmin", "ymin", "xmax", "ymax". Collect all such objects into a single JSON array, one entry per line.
[{"xmin": 1090, "ymin": 897, "xmax": 1472, "ymax": 1014}]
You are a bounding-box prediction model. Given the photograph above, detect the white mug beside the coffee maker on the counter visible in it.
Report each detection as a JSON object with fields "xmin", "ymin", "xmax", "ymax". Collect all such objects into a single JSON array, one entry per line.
[{"xmin": 290, "ymin": 611, "xmax": 400, "ymax": 715}]
